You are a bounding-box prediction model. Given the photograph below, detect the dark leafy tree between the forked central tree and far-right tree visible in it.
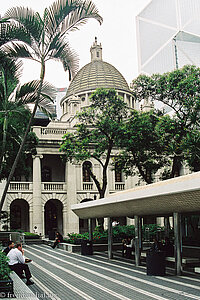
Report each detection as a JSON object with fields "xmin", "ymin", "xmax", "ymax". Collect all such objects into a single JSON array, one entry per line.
[{"xmin": 115, "ymin": 111, "xmax": 168, "ymax": 184}]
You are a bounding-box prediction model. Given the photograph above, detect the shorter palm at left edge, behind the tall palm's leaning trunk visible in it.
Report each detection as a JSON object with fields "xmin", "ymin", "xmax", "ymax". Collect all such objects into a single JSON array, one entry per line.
[{"xmin": 0, "ymin": 52, "xmax": 56, "ymax": 179}]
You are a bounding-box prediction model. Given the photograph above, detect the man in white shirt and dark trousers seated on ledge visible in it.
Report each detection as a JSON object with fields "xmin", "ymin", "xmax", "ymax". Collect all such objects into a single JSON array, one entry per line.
[{"xmin": 7, "ymin": 244, "xmax": 34, "ymax": 285}]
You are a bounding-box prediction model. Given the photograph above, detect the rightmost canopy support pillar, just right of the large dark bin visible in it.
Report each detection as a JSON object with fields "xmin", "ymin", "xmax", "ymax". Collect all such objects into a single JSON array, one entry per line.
[{"xmin": 173, "ymin": 213, "xmax": 182, "ymax": 275}]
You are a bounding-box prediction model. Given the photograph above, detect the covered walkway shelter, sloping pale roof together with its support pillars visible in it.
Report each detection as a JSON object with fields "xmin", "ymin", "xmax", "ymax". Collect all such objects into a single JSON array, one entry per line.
[{"xmin": 71, "ymin": 172, "xmax": 200, "ymax": 275}]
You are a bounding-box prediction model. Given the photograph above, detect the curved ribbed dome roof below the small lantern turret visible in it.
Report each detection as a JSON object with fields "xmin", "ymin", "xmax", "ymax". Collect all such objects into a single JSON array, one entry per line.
[{"xmin": 66, "ymin": 60, "xmax": 130, "ymax": 97}]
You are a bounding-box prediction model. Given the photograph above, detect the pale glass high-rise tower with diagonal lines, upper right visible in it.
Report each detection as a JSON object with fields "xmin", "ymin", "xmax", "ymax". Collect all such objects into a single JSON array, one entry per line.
[{"xmin": 136, "ymin": 0, "xmax": 200, "ymax": 74}]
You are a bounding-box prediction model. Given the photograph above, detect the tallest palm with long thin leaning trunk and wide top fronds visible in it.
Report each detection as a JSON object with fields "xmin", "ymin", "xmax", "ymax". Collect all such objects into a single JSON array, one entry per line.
[{"xmin": 0, "ymin": 0, "xmax": 102, "ymax": 210}]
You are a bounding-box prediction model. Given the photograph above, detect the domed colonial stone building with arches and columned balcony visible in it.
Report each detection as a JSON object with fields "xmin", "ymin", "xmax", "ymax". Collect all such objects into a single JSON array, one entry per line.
[{"xmin": 4, "ymin": 39, "xmax": 140, "ymax": 236}]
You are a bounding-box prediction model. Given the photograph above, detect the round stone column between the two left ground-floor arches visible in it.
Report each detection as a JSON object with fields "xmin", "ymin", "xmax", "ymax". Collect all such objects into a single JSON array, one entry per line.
[{"xmin": 32, "ymin": 155, "xmax": 44, "ymax": 235}]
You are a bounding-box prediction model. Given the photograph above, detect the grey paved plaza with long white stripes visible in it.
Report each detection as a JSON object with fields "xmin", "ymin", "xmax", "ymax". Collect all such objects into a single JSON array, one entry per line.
[{"xmin": 16, "ymin": 244, "xmax": 200, "ymax": 300}]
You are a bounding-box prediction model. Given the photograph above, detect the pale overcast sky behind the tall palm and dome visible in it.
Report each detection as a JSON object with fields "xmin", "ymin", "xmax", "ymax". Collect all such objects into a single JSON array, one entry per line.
[{"xmin": 0, "ymin": 0, "xmax": 151, "ymax": 87}]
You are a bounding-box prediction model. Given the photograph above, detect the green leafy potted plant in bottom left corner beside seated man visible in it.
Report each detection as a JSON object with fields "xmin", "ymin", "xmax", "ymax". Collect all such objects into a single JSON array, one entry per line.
[{"xmin": 0, "ymin": 249, "xmax": 13, "ymax": 298}]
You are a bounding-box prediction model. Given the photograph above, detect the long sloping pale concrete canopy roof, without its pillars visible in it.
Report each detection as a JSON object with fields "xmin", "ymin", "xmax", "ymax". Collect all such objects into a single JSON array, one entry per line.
[{"xmin": 71, "ymin": 172, "xmax": 200, "ymax": 219}]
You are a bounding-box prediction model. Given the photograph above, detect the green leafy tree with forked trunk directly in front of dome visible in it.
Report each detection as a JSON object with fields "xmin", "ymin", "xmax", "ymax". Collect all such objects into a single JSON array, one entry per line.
[{"xmin": 60, "ymin": 88, "xmax": 128, "ymax": 227}]
